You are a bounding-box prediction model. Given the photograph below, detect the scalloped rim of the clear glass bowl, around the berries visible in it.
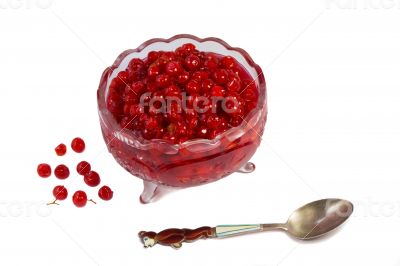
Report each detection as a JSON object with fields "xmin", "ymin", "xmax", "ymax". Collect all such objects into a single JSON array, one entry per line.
[{"xmin": 97, "ymin": 34, "xmax": 268, "ymax": 151}]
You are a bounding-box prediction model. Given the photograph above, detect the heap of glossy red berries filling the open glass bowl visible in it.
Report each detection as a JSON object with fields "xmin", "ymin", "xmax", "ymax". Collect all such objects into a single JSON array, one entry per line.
[{"xmin": 107, "ymin": 43, "xmax": 259, "ymax": 143}]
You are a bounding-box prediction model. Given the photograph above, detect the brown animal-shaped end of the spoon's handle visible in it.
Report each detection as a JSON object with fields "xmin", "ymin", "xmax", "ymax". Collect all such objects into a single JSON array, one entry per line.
[{"xmin": 139, "ymin": 226, "xmax": 215, "ymax": 248}]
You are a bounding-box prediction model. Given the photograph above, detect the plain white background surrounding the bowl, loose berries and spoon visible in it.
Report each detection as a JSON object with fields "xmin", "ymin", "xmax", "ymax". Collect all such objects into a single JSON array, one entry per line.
[{"xmin": 0, "ymin": 0, "xmax": 400, "ymax": 266}]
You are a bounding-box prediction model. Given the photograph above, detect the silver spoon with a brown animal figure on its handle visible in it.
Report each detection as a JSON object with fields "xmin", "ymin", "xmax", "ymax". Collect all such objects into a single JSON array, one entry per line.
[{"xmin": 139, "ymin": 199, "xmax": 353, "ymax": 248}]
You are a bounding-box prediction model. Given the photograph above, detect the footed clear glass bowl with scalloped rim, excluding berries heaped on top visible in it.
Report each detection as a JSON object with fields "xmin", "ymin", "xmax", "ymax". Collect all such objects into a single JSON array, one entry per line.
[{"xmin": 97, "ymin": 34, "xmax": 267, "ymax": 203}]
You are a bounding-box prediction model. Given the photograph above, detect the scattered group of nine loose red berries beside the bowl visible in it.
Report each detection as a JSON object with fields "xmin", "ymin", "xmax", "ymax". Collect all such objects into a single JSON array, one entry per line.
[{"xmin": 37, "ymin": 138, "xmax": 113, "ymax": 207}]
